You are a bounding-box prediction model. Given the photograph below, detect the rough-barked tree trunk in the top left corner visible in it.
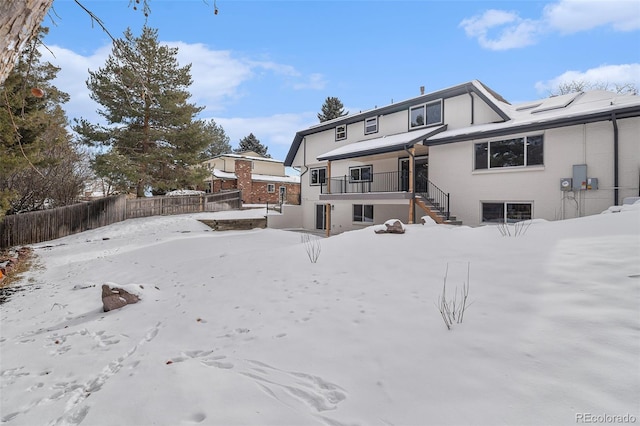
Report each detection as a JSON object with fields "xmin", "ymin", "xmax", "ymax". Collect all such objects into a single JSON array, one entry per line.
[{"xmin": 0, "ymin": 0, "xmax": 53, "ymax": 84}]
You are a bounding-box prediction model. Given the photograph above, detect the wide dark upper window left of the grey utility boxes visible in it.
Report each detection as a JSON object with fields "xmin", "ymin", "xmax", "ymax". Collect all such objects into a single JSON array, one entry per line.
[{"xmin": 474, "ymin": 135, "xmax": 544, "ymax": 170}]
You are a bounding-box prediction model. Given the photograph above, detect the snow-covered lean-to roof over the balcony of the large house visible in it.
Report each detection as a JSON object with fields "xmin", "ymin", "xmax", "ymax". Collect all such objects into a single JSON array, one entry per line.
[{"xmin": 317, "ymin": 125, "xmax": 447, "ymax": 160}]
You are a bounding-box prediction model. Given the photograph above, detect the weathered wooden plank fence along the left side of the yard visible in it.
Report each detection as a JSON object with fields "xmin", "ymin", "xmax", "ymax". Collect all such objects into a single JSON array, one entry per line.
[{"xmin": 0, "ymin": 191, "xmax": 242, "ymax": 249}]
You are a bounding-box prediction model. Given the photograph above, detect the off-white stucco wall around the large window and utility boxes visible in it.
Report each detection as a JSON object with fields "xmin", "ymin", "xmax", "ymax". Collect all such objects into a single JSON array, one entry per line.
[{"xmin": 429, "ymin": 120, "xmax": 639, "ymax": 226}]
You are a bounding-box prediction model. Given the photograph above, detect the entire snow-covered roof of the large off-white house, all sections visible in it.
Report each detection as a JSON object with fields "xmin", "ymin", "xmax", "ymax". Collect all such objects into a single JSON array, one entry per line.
[{"xmin": 284, "ymin": 80, "xmax": 640, "ymax": 166}]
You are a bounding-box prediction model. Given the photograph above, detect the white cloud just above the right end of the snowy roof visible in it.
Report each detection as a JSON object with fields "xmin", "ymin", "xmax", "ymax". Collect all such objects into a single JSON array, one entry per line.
[{"xmin": 535, "ymin": 63, "xmax": 640, "ymax": 96}]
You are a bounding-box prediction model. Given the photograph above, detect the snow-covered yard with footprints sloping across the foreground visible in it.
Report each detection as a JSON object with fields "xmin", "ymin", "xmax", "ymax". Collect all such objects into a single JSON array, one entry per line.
[{"xmin": 0, "ymin": 205, "xmax": 640, "ymax": 426}]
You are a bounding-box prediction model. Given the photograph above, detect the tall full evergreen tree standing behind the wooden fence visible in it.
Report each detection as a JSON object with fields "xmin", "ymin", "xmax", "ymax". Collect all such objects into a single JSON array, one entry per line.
[{"xmin": 74, "ymin": 26, "xmax": 210, "ymax": 197}]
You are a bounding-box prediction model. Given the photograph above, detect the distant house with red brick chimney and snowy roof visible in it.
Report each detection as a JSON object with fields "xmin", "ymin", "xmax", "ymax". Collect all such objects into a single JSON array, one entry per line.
[{"xmin": 203, "ymin": 151, "xmax": 300, "ymax": 204}]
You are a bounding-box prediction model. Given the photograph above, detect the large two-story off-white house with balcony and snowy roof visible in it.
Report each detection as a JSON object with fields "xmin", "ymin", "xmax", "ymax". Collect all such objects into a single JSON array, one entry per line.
[{"xmin": 284, "ymin": 80, "xmax": 640, "ymax": 234}]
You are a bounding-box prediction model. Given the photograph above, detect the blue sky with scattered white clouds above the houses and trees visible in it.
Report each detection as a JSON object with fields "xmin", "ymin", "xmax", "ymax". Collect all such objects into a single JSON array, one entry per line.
[{"xmin": 43, "ymin": 0, "xmax": 640, "ymax": 160}]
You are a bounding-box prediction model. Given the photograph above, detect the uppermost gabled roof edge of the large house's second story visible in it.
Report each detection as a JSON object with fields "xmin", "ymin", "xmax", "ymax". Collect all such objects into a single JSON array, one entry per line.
[{"xmin": 284, "ymin": 80, "xmax": 510, "ymax": 166}]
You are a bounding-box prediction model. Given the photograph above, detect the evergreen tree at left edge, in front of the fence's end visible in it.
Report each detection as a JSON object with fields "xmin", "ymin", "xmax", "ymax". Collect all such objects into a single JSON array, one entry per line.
[{"xmin": 0, "ymin": 28, "xmax": 86, "ymax": 218}]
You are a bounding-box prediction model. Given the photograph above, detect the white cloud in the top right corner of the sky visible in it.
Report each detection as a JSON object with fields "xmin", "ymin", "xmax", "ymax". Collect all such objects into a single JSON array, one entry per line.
[{"xmin": 460, "ymin": 0, "xmax": 640, "ymax": 50}]
